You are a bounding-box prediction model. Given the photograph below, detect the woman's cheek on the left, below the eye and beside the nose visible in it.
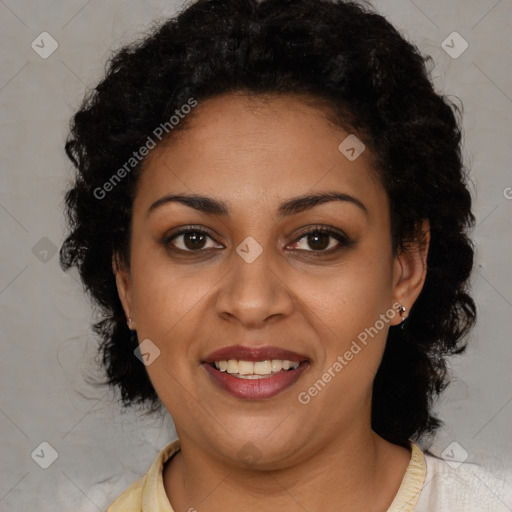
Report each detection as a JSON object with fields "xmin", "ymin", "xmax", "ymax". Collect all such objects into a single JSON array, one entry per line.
[{"xmin": 127, "ymin": 256, "xmax": 212, "ymax": 410}]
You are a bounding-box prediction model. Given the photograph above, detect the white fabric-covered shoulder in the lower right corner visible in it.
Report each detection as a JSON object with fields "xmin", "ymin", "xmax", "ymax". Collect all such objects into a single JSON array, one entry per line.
[{"xmin": 414, "ymin": 451, "xmax": 512, "ymax": 512}]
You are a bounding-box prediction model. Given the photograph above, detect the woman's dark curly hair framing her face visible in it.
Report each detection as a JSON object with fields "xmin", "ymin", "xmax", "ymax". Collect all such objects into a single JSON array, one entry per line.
[{"xmin": 60, "ymin": 0, "xmax": 476, "ymax": 444}]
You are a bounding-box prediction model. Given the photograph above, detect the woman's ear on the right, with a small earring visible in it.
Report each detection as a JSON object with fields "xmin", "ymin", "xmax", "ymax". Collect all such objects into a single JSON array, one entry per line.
[{"xmin": 390, "ymin": 220, "xmax": 430, "ymax": 325}]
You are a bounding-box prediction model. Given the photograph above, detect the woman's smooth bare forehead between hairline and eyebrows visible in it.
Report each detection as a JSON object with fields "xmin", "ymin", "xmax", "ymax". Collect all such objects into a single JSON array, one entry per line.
[{"xmin": 137, "ymin": 94, "xmax": 387, "ymax": 215}]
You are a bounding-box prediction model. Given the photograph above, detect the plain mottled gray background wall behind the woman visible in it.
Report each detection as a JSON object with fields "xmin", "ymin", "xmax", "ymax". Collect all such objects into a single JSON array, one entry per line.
[{"xmin": 0, "ymin": 0, "xmax": 512, "ymax": 512}]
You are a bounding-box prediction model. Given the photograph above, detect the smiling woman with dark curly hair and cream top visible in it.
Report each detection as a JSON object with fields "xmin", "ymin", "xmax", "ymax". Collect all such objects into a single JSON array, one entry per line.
[{"xmin": 61, "ymin": 0, "xmax": 505, "ymax": 512}]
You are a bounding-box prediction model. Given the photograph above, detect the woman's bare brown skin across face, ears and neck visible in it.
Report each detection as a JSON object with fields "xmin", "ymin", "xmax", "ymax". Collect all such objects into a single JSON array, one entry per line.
[{"xmin": 114, "ymin": 94, "xmax": 428, "ymax": 512}]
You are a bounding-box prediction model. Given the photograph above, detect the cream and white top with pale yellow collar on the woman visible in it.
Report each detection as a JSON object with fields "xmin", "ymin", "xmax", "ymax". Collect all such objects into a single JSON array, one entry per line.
[{"xmin": 106, "ymin": 439, "xmax": 512, "ymax": 512}]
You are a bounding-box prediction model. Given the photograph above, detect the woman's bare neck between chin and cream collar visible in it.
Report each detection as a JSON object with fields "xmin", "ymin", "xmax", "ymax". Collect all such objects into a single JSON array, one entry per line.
[{"xmin": 164, "ymin": 429, "xmax": 410, "ymax": 512}]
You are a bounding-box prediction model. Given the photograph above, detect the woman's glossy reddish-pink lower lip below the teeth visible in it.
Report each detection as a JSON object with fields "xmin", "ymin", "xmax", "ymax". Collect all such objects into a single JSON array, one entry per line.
[{"xmin": 202, "ymin": 361, "xmax": 309, "ymax": 400}]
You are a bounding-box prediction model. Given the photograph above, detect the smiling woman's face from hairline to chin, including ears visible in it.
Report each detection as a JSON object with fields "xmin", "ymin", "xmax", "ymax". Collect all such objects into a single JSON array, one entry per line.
[{"xmin": 117, "ymin": 94, "xmax": 425, "ymax": 467}]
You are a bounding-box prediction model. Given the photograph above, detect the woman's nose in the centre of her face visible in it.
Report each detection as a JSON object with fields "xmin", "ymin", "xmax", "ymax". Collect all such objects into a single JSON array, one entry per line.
[{"xmin": 215, "ymin": 243, "xmax": 294, "ymax": 329}]
